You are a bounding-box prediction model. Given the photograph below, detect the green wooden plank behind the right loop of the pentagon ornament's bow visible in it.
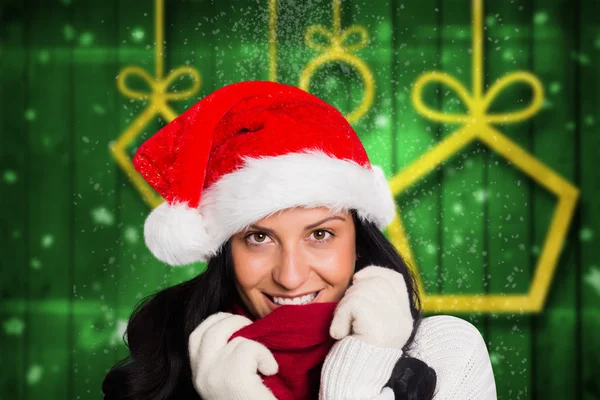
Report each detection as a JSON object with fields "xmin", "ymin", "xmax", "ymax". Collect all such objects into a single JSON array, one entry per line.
[{"xmin": 484, "ymin": 2, "xmax": 537, "ymax": 399}]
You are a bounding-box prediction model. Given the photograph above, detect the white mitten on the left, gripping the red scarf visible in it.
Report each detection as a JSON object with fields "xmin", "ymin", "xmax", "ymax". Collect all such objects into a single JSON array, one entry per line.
[{"xmin": 188, "ymin": 312, "xmax": 279, "ymax": 400}]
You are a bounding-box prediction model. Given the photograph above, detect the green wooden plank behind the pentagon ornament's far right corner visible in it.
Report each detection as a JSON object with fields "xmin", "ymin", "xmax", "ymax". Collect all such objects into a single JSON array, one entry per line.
[{"xmin": 533, "ymin": 1, "xmax": 579, "ymax": 399}]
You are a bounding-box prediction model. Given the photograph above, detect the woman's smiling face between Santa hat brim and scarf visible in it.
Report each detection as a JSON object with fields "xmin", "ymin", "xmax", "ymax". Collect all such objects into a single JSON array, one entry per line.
[{"xmin": 231, "ymin": 207, "xmax": 356, "ymax": 318}]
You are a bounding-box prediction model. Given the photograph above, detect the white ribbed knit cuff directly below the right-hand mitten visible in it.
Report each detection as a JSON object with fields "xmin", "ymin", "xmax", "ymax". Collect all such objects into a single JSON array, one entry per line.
[{"xmin": 319, "ymin": 336, "xmax": 402, "ymax": 400}]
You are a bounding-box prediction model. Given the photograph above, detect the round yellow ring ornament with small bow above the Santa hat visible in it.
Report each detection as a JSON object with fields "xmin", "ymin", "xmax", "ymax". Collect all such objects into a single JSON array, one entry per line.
[{"xmin": 299, "ymin": 0, "xmax": 375, "ymax": 123}]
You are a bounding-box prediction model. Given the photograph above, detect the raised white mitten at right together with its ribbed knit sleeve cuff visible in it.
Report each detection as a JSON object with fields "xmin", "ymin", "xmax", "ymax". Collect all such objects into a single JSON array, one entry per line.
[{"xmin": 319, "ymin": 265, "xmax": 413, "ymax": 400}]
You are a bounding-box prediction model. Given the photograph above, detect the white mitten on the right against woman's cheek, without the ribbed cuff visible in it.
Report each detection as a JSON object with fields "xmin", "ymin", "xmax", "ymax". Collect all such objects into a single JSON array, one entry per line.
[{"xmin": 329, "ymin": 265, "xmax": 413, "ymax": 349}]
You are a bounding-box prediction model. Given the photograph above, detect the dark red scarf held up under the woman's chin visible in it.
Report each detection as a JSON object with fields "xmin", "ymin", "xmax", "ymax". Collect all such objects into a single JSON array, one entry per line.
[{"xmin": 229, "ymin": 296, "xmax": 337, "ymax": 400}]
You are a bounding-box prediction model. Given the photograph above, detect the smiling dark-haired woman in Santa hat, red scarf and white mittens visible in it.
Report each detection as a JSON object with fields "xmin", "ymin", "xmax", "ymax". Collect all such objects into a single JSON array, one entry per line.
[{"xmin": 103, "ymin": 82, "xmax": 495, "ymax": 400}]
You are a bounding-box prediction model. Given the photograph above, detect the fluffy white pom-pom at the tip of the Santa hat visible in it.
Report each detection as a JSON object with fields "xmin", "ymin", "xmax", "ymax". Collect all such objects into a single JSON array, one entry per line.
[{"xmin": 144, "ymin": 202, "xmax": 217, "ymax": 266}]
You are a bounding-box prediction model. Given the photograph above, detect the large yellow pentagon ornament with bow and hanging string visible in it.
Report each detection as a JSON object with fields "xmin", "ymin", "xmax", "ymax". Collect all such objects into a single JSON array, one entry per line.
[{"xmin": 387, "ymin": 0, "xmax": 579, "ymax": 313}]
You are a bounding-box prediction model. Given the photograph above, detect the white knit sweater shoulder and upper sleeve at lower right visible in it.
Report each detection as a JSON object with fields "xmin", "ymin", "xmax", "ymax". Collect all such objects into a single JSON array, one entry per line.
[{"xmin": 408, "ymin": 315, "xmax": 497, "ymax": 400}]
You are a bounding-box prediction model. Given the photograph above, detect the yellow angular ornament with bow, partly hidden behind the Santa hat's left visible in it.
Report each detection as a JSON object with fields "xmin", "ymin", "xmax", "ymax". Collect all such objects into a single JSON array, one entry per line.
[{"xmin": 110, "ymin": 0, "xmax": 201, "ymax": 208}]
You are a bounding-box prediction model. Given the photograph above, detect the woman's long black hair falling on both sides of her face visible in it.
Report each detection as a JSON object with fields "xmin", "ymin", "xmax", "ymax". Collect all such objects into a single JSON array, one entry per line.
[{"xmin": 102, "ymin": 210, "xmax": 436, "ymax": 400}]
